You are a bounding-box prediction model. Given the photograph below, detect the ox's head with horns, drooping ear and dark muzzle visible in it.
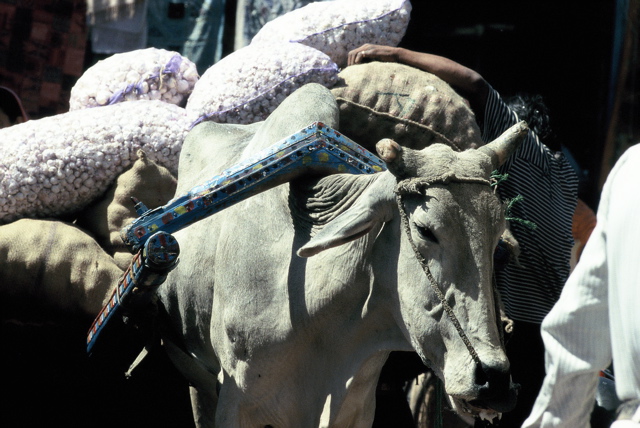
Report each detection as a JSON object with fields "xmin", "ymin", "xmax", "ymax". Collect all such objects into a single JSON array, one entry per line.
[{"xmin": 298, "ymin": 122, "xmax": 528, "ymax": 420}]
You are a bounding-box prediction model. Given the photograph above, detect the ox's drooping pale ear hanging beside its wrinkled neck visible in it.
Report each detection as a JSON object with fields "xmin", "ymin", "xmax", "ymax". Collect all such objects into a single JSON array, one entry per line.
[{"xmin": 297, "ymin": 172, "xmax": 396, "ymax": 257}]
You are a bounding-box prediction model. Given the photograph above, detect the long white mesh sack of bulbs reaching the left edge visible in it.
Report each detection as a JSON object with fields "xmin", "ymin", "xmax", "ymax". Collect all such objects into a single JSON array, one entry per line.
[{"xmin": 0, "ymin": 100, "xmax": 189, "ymax": 224}]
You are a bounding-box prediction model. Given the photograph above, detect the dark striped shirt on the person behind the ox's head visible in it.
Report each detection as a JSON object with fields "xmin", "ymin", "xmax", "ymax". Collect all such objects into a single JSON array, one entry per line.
[{"xmin": 482, "ymin": 88, "xmax": 578, "ymax": 323}]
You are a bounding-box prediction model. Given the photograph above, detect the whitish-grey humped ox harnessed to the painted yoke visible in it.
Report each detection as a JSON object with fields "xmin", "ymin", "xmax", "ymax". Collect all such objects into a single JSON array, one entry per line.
[{"xmin": 161, "ymin": 84, "xmax": 526, "ymax": 428}]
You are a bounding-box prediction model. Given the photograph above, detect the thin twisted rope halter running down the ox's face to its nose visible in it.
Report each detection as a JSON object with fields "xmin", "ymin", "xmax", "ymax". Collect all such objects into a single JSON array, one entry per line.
[{"xmin": 395, "ymin": 179, "xmax": 489, "ymax": 367}]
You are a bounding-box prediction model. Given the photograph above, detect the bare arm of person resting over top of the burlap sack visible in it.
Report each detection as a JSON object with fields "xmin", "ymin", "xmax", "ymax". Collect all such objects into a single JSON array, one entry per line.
[{"xmin": 348, "ymin": 44, "xmax": 489, "ymax": 123}]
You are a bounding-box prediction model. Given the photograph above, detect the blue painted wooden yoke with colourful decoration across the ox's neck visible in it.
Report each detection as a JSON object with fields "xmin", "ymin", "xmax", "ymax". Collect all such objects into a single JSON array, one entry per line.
[{"xmin": 87, "ymin": 122, "xmax": 386, "ymax": 354}]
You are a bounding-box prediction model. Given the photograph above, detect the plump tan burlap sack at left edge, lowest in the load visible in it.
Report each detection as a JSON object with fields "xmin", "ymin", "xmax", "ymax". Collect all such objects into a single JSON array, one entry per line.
[{"xmin": 0, "ymin": 219, "xmax": 123, "ymax": 316}]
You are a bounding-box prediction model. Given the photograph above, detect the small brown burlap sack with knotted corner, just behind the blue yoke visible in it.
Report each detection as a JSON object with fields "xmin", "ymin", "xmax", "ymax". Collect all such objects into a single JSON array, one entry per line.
[{"xmin": 76, "ymin": 150, "xmax": 177, "ymax": 270}]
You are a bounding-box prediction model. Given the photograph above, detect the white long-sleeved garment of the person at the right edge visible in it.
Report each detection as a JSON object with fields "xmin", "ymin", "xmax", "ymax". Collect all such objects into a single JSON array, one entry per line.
[{"xmin": 523, "ymin": 145, "xmax": 640, "ymax": 428}]
